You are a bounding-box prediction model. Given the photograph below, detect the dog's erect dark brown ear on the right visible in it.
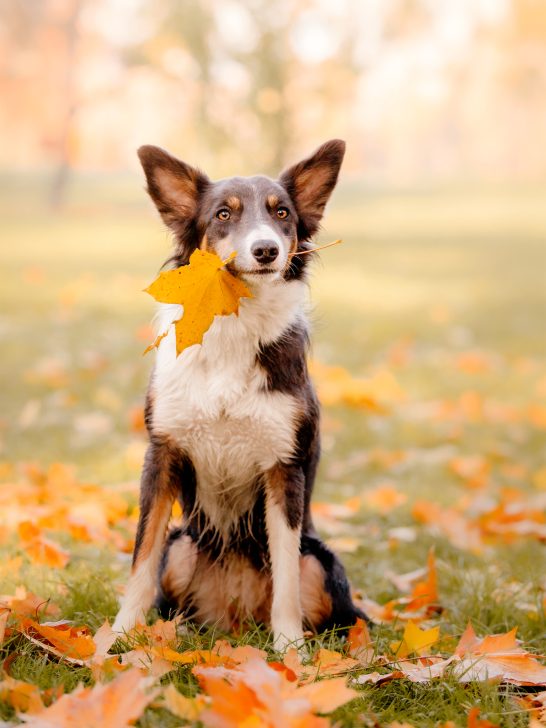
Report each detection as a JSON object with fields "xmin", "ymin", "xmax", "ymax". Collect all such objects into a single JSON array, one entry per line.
[{"xmin": 279, "ymin": 139, "xmax": 345, "ymax": 240}]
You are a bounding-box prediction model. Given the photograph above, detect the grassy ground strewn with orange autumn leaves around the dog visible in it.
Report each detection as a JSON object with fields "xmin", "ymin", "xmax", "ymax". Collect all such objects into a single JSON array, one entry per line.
[{"xmin": 0, "ymin": 180, "xmax": 546, "ymax": 728}]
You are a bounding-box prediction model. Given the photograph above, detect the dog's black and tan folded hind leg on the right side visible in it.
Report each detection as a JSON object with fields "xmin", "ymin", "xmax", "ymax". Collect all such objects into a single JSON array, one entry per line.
[{"xmin": 301, "ymin": 534, "xmax": 366, "ymax": 632}]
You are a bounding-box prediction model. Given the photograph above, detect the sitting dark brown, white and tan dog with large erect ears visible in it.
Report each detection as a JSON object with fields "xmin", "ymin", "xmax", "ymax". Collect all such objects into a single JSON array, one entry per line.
[{"xmin": 114, "ymin": 139, "xmax": 364, "ymax": 649}]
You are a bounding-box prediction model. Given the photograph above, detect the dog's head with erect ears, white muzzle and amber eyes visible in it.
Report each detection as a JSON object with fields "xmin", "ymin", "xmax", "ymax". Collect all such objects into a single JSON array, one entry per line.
[{"xmin": 138, "ymin": 139, "xmax": 345, "ymax": 282}]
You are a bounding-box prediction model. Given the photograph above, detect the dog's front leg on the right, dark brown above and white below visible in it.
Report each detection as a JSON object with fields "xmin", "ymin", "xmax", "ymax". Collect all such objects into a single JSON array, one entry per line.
[{"xmin": 265, "ymin": 464, "xmax": 304, "ymax": 650}]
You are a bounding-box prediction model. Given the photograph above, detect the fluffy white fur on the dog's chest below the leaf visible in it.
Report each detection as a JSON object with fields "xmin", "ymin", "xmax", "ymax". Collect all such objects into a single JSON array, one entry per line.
[{"xmin": 152, "ymin": 280, "xmax": 306, "ymax": 531}]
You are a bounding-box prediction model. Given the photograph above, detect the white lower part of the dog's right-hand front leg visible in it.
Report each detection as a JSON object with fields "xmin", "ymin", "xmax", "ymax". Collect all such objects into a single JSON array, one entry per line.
[{"xmin": 265, "ymin": 493, "xmax": 303, "ymax": 650}]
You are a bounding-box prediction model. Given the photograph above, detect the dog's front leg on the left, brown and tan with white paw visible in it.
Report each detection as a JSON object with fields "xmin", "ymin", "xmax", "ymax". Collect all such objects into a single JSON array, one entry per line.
[{"xmin": 113, "ymin": 437, "xmax": 175, "ymax": 632}]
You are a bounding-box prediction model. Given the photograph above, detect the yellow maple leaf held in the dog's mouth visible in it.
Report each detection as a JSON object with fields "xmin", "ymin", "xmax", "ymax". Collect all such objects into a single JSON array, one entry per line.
[{"xmin": 140, "ymin": 250, "xmax": 252, "ymax": 356}]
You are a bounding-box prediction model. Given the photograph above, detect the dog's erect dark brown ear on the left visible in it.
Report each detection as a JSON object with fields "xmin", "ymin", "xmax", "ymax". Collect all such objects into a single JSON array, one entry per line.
[{"xmin": 138, "ymin": 145, "xmax": 211, "ymax": 243}]
